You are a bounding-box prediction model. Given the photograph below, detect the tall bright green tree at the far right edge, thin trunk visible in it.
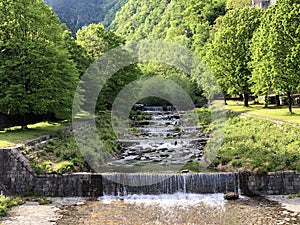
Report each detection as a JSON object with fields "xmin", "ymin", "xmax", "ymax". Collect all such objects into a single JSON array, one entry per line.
[{"xmin": 251, "ymin": 0, "xmax": 300, "ymax": 113}]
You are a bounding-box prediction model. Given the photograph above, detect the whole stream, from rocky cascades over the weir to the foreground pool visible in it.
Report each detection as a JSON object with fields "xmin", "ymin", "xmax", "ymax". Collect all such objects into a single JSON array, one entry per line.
[{"xmin": 4, "ymin": 106, "xmax": 300, "ymax": 225}]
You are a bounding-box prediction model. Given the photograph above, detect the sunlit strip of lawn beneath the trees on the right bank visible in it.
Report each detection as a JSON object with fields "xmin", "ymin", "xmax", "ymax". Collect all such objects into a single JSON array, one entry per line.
[{"xmin": 225, "ymin": 101, "xmax": 300, "ymax": 124}]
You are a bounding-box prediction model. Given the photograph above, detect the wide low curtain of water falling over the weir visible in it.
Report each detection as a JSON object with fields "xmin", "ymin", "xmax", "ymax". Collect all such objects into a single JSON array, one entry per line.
[{"xmin": 102, "ymin": 173, "xmax": 239, "ymax": 196}]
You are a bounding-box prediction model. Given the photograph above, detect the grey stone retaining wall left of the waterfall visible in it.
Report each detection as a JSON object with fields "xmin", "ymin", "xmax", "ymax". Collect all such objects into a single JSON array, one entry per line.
[{"xmin": 0, "ymin": 147, "xmax": 102, "ymax": 197}]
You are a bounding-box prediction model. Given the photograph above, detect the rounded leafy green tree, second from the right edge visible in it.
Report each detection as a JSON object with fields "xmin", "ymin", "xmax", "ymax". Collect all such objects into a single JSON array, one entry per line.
[{"xmin": 205, "ymin": 7, "xmax": 261, "ymax": 107}]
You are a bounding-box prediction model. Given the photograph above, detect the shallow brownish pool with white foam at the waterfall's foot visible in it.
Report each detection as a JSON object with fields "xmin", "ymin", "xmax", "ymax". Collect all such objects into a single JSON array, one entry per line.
[{"xmin": 58, "ymin": 193, "xmax": 300, "ymax": 225}]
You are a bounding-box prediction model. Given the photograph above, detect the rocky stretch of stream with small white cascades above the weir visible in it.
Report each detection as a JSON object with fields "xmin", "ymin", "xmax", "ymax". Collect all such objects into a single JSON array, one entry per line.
[{"xmin": 98, "ymin": 106, "xmax": 209, "ymax": 173}]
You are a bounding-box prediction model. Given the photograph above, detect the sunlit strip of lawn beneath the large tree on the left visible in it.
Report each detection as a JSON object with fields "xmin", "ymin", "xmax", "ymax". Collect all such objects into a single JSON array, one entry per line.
[{"xmin": 0, "ymin": 122, "xmax": 68, "ymax": 148}]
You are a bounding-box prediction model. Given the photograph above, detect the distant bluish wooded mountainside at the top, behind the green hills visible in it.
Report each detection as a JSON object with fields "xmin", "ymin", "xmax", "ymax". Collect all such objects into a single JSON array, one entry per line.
[{"xmin": 45, "ymin": 0, "xmax": 127, "ymax": 35}]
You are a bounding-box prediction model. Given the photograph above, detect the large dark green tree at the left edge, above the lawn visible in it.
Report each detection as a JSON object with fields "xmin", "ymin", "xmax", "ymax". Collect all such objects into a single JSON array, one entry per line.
[{"xmin": 0, "ymin": 0, "xmax": 78, "ymax": 128}]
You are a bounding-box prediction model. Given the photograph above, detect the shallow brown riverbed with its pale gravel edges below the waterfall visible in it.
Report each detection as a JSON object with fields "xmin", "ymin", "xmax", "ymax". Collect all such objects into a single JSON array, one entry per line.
[{"xmin": 2, "ymin": 193, "xmax": 300, "ymax": 225}]
